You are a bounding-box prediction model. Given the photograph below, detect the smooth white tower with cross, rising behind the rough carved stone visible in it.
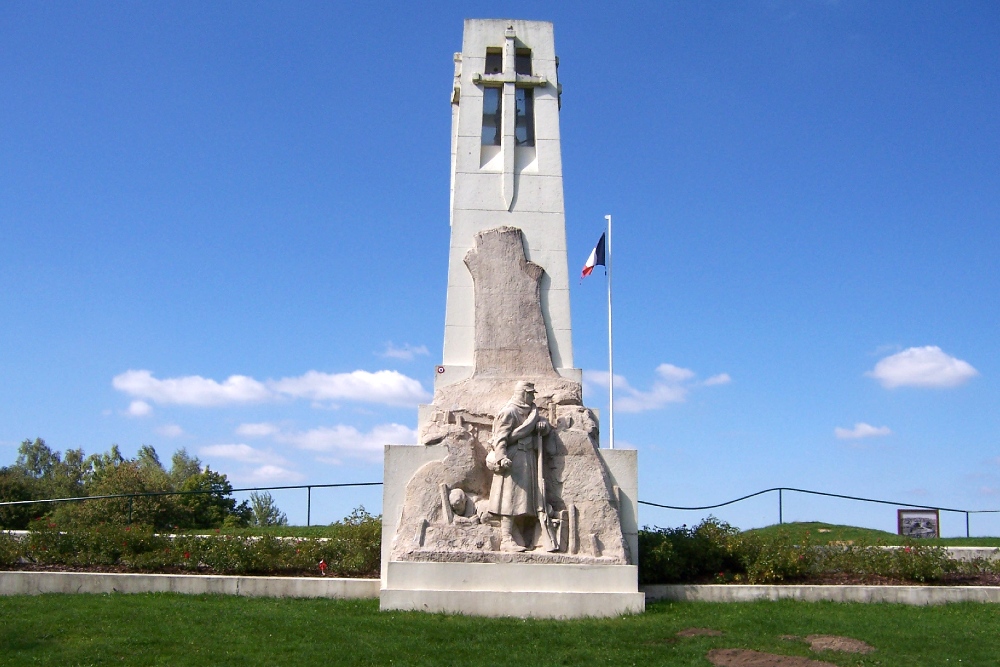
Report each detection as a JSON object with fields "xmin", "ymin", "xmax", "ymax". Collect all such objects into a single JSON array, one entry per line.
[{"xmin": 436, "ymin": 19, "xmax": 580, "ymax": 387}]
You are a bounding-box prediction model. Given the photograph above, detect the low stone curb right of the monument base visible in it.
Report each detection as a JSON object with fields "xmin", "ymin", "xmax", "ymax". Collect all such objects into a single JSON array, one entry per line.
[{"xmin": 639, "ymin": 584, "xmax": 1000, "ymax": 605}]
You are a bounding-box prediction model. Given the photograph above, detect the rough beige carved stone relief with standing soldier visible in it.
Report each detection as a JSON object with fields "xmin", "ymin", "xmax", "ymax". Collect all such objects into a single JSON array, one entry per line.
[{"xmin": 390, "ymin": 227, "xmax": 629, "ymax": 564}]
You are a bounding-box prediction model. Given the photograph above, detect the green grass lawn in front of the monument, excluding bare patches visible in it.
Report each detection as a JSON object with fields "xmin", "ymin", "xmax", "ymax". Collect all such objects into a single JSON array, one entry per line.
[{"xmin": 0, "ymin": 594, "xmax": 1000, "ymax": 667}]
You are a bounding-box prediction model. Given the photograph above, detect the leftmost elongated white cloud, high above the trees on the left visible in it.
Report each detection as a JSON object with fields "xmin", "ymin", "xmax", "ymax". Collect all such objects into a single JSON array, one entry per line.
[{"xmin": 111, "ymin": 370, "xmax": 270, "ymax": 406}]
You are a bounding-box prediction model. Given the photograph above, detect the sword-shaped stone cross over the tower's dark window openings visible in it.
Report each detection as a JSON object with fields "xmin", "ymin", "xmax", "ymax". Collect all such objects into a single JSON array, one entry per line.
[{"xmin": 472, "ymin": 25, "xmax": 548, "ymax": 211}]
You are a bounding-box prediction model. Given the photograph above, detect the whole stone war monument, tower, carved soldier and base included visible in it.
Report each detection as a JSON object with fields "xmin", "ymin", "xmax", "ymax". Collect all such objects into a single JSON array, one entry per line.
[{"xmin": 381, "ymin": 20, "xmax": 644, "ymax": 618}]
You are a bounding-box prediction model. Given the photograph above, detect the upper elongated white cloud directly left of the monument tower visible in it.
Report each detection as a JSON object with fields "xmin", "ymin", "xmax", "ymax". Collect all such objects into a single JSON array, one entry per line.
[{"xmin": 270, "ymin": 371, "xmax": 430, "ymax": 406}]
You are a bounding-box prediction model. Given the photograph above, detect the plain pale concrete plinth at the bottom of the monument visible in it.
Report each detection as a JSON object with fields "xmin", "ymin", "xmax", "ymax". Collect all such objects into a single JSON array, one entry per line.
[{"xmin": 379, "ymin": 561, "xmax": 646, "ymax": 618}]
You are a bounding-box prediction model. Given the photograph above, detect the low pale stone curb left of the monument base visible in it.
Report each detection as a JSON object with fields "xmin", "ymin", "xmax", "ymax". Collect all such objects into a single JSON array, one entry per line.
[{"xmin": 0, "ymin": 571, "xmax": 380, "ymax": 599}]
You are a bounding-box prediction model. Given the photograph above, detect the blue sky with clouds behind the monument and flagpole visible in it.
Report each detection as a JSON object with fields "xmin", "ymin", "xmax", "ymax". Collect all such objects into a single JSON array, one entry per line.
[{"xmin": 0, "ymin": 1, "xmax": 1000, "ymax": 535}]
